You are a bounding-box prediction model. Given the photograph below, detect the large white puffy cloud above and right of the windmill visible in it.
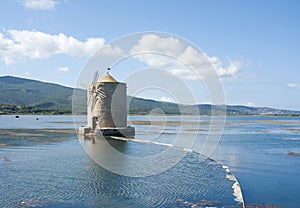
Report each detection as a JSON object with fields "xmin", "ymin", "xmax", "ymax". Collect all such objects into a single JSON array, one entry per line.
[{"xmin": 130, "ymin": 34, "xmax": 244, "ymax": 80}]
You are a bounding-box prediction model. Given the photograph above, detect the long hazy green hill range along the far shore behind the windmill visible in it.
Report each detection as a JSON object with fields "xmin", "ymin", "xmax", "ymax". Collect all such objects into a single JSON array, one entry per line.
[{"xmin": 0, "ymin": 76, "xmax": 300, "ymax": 116}]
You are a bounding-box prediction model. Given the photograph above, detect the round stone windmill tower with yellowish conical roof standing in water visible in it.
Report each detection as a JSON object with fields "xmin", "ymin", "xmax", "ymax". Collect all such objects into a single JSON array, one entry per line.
[{"xmin": 80, "ymin": 68, "xmax": 135, "ymax": 137}]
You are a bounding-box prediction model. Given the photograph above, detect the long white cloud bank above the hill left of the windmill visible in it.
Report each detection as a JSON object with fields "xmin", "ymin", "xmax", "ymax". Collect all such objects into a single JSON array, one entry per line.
[{"xmin": 0, "ymin": 30, "xmax": 107, "ymax": 65}]
